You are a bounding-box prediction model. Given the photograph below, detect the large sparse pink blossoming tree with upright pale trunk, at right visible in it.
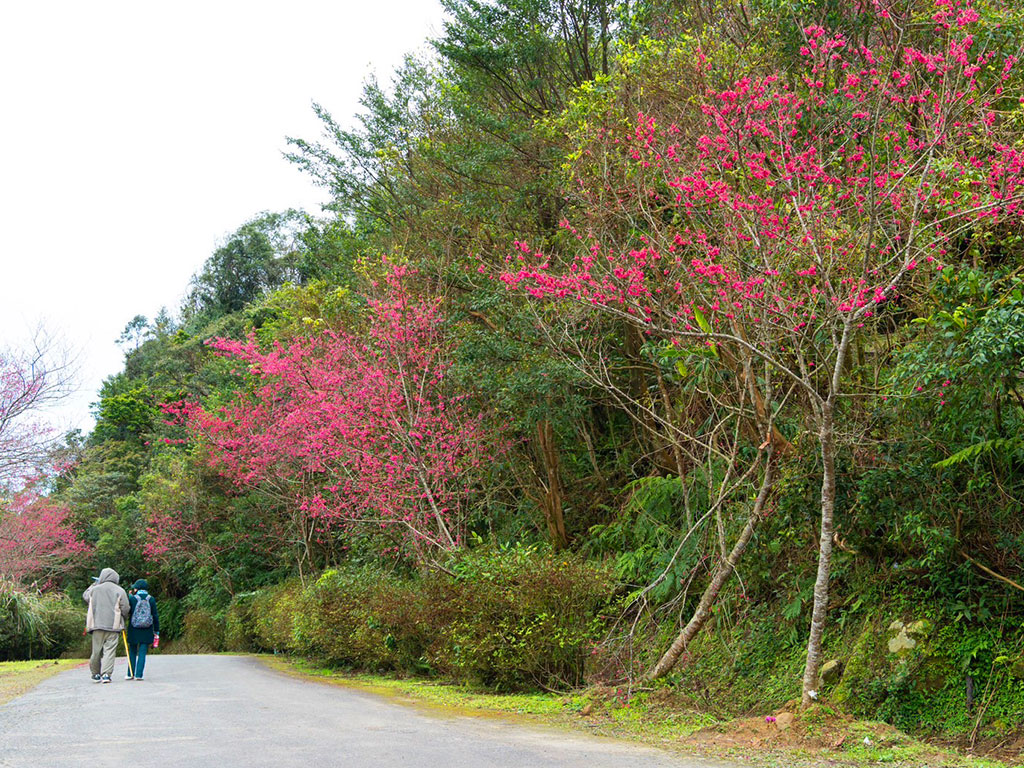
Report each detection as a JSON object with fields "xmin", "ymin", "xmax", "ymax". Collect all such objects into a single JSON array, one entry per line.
[{"xmin": 502, "ymin": 0, "xmax": 1024, "ymax": 706}]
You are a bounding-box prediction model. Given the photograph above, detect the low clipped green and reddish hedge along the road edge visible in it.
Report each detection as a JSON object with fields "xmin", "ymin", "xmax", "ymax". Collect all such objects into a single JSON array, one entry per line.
[{"xmin": 203, "ymin": 547, "xmax": 615, "ymax": 690}]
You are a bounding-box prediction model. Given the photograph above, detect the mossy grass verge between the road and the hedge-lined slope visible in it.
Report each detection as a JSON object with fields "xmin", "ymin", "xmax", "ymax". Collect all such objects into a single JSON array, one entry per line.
[{"xmin": 259, "ymin": 656, "xmax": 1008, "ymax": 768}]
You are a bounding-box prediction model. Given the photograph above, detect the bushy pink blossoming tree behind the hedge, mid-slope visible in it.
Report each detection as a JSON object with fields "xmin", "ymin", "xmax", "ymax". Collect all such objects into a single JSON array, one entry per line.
[{"xmin": 184, "ymin": 265, "xmax": 502, "ymax": 567}]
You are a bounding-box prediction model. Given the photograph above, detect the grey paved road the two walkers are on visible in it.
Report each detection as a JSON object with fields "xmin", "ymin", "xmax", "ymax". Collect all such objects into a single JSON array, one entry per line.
[{"xmin": 0, "ymin": 655, "xmax": 737, "ymax": 768}]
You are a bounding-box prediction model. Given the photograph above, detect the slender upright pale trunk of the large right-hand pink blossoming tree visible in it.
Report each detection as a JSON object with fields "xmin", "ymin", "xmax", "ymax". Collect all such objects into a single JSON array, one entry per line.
[{"xmin": 801, "ymin": 398, "xmax": 836, "ymax": 708}]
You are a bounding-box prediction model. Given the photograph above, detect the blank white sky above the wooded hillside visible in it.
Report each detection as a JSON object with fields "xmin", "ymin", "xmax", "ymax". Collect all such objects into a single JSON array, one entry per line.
[{"xmin": 0, "ymin": 0, "xmax": 442, "ymax": 430}]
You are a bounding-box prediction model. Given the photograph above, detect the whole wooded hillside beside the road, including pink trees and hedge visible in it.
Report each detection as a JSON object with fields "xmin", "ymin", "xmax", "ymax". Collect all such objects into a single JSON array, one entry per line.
[{"xmin": 0, "ymin": 0, "xmax": 1024, "ymax": 752}]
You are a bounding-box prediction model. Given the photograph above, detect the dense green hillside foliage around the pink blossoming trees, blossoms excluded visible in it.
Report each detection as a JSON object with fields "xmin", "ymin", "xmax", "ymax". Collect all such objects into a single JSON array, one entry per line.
[{"xmin": 9, "ymin": 0, "xmax": 1024, "ymax": 757}]
